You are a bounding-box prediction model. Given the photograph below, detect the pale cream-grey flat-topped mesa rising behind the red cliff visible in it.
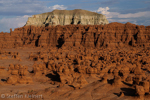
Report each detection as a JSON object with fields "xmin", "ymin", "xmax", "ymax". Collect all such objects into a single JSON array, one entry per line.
[{"xmin": 25, "ymin": 9, "xmax": 109, "ymax": 26}]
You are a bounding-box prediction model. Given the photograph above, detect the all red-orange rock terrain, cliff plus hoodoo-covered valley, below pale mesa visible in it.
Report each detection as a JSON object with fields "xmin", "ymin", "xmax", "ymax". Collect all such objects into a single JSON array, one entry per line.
[{"xmin": 0, "ymin": 22, "xmax": 150, "ymax": 100}]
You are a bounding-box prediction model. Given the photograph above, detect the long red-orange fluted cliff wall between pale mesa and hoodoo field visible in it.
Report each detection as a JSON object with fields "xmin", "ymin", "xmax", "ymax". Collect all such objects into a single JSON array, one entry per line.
[{"xmin": 0, "ymin": 23, "xmax": 150, "ymax": 48}]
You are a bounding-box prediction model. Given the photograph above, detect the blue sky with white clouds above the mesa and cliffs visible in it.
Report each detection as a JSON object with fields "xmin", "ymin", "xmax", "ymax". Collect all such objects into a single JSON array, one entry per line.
[{"xmin": 0, "ymin": 0, "xmax": 150, "ymax": 32}]
